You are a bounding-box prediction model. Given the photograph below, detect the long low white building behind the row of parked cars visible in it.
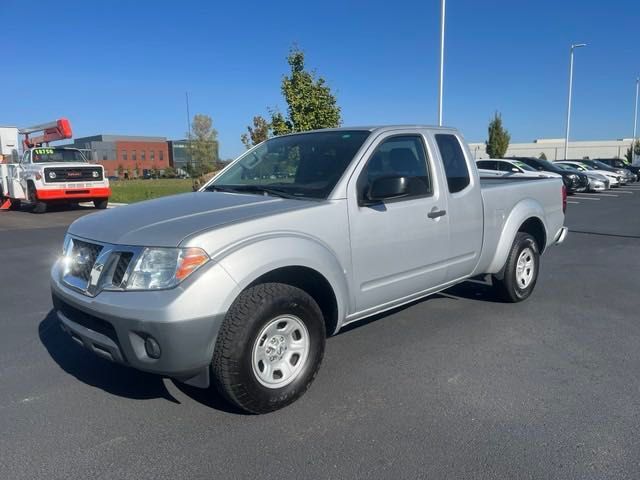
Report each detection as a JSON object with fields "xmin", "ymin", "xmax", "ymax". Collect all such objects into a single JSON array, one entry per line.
[{"xmin": 469, "ymin": 138, "xmax": 632, "ymax": 161}]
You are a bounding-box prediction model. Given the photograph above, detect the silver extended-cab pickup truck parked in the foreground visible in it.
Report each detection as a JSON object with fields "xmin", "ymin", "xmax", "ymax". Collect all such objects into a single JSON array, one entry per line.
[{"xmin": 51, "ymin": 126, "xmax": 567, "ymax": 413}]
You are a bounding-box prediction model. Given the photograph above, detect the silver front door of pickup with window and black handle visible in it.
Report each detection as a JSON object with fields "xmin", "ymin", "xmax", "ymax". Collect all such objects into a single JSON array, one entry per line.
[{"xmin": 348, "ymin": 131, "xmax": 449, "ymax": 313}]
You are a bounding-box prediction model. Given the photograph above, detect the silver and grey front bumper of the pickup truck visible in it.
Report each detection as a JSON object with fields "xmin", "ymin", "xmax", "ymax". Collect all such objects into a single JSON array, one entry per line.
[{"xmin": 51, "ymin": 256, "xmax": 237, "ymax": 387}]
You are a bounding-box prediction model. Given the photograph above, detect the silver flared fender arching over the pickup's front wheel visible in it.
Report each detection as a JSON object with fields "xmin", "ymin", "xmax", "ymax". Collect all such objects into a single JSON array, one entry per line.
[{"xmin": 211, "ymin": 231, "xmax": 350, "ymax": 333}]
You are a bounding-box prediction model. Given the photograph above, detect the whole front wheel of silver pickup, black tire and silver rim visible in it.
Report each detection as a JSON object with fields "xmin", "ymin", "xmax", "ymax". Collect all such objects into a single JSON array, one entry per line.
[{"xmin": 211, "ymin": 283, "xmax": 325, "ymax": 413}]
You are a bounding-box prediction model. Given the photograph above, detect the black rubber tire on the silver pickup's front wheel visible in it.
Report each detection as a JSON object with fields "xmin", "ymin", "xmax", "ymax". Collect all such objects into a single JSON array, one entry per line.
[{"xmin": 211, "ymin": 283, "xmax": 326, "ymax": 413}]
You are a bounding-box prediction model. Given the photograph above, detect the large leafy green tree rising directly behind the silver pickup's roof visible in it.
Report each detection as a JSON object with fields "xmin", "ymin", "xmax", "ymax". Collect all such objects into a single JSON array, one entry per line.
[{"xmin": 269, "ymin": 47, "xmax": 341, "ymax": 135}]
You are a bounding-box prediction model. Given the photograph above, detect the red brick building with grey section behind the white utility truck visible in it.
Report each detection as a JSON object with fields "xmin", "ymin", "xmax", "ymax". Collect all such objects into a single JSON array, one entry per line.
[{"xmin": 66, "ymin": 135, "xmax": 169, "ymax": 178}]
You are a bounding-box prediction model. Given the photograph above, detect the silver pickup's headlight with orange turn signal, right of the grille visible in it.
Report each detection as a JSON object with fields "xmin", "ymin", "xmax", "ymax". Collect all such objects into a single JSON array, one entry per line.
[{"xmin": 126, "ymin": 247, "xmax": 209, "ymax": 290}]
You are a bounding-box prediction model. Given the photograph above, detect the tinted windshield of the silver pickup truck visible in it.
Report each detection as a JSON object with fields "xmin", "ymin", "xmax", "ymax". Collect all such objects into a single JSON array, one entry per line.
[{"xmin": 206, "ymin": 130, "xmax": 371, "ymax": 198}]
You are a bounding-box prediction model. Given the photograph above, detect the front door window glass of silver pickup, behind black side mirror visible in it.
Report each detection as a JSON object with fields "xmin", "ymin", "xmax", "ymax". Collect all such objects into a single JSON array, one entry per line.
[{"xmin": 358, "ymin": 135, "xmax": 432, "ymax": 200}]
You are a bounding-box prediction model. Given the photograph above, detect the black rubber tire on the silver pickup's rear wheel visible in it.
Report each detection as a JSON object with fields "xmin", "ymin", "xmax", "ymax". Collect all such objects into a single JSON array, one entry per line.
[{"xmin": 493, "ymin": 232, "xmax": 540, "ymax": 303}]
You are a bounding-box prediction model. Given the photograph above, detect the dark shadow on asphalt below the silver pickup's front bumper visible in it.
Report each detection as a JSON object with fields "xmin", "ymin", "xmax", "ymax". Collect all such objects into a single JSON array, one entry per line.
[{"xmin": 38, "ymin": 310, "xmax": 239, "ymax": 413}]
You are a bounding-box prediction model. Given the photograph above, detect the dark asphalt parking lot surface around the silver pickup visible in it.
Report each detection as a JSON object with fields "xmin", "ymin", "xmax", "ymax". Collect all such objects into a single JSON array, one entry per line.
[{"xmin": 0, "ymin": 186, "xmax": 640, "ymax": 479}]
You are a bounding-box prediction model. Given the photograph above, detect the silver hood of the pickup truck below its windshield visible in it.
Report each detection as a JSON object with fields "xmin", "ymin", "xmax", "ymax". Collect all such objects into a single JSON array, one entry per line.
[{"xmin": 69, "ymin": 192, "xmax": 319, "ymax": 247}]
